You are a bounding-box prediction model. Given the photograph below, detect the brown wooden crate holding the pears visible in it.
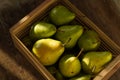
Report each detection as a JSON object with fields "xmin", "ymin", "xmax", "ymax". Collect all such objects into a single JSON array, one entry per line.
[{"xmin": 10, "ymin": 0, "xmax": 120, "ymax": 80}]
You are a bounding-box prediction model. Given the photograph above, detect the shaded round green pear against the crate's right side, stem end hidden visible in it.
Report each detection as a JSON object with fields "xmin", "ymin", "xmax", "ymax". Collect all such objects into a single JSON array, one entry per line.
[{"xmin": 78, "ymin": 30, "xmax": 101, "ymax": 51}]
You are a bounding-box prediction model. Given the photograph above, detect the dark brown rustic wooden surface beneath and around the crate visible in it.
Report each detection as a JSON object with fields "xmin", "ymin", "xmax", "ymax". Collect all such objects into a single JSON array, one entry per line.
[{"xmin": 0, "ymin": 0, "xmax": 120, "ymax": 80}]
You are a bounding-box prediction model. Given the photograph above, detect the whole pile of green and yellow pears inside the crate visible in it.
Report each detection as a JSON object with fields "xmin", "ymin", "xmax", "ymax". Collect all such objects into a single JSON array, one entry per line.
[{"xmin": 22, "ymin": 5, "xmax": 112, "ymax": 80}]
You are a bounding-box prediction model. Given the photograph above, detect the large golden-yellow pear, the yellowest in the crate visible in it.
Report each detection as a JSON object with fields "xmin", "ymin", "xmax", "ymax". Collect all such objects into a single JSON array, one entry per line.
[{"xmin": 32, "ymin": 38, "xmax": 64, "ymax": 66}]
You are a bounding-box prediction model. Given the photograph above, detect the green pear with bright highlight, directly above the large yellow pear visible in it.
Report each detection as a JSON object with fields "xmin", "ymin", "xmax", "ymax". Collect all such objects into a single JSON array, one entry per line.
[{"xmin": 29, "ymin": 22, "xmax": 56, "ymax": 40}]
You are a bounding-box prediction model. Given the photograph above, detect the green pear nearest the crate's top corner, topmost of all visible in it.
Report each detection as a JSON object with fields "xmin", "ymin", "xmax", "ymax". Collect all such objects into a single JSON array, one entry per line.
[{"xmin": 49, "ymin": 5, "xmax": 75, "ymax": 25}]
